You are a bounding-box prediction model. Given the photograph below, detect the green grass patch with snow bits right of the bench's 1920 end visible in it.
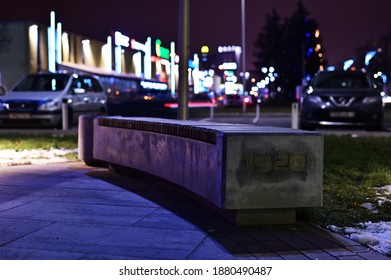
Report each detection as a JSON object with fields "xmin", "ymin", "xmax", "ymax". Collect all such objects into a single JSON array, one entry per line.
[{"xmin": 301, "ymin": 136, "xmax": 391, "ymax": 227}]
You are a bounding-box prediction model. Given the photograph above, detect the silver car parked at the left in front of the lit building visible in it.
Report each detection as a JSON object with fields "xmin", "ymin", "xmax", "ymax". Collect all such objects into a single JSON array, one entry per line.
[{"xmin": 0, "ymin": 73, "xmax": 106, "ymax": 127}]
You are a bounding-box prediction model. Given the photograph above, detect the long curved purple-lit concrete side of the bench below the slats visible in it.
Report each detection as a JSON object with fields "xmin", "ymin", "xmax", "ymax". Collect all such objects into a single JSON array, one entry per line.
[{"xmin": 93, "ymin": 126, "xmax": 224, "ymax": 207}]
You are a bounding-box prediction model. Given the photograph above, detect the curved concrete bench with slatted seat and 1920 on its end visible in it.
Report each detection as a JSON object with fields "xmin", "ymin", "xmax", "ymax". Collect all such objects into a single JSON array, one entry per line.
[{"xmin": 79, "ymin": 116, "xmax": 323, "ymax": 225}]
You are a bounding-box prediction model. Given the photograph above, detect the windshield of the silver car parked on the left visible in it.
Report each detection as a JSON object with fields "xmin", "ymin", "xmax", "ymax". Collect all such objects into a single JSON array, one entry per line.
[{"xmin": 13, "ymin": 74, "xmax": 69, "ymax": 91}]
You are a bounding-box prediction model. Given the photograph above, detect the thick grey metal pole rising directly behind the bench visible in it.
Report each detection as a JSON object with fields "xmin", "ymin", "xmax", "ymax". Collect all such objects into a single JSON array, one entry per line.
[{"xmin": 178, "ymin": 0, "xmax": 190, "ymax": 120}]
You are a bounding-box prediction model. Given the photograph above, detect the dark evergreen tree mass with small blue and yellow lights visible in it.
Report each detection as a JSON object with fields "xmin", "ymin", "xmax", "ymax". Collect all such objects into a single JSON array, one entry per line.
[{"xmin": 254, "ymin": 0, "xmax": 326, "ymax": 101}]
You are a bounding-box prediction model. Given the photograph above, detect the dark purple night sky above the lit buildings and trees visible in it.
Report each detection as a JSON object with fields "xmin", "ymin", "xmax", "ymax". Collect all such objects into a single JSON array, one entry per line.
[{"xmin": 0, "ymin": 0, "xmax": 391, "ymax": 69}]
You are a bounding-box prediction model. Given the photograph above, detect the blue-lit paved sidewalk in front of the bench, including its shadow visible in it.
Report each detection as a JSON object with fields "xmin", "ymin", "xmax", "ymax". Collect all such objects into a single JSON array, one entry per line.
[{"xmin": 0, "ymin": 162, "xmax": 390, "ymax": 260}]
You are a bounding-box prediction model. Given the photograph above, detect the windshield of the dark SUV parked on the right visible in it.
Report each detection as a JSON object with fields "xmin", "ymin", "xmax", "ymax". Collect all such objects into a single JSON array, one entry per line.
[{"xmin": 315, "ymin": 73, "xmax": 371, "ymax": 88}]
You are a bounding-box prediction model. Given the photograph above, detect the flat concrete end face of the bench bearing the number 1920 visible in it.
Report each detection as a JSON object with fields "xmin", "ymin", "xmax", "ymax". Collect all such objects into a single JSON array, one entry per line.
[{"xmin": 225, "ymin": 132, "xmax": 323, "ymax": 209}]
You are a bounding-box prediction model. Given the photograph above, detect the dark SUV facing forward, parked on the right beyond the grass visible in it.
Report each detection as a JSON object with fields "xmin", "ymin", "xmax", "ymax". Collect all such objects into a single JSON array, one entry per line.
[{"xmin": 300, "ymin": 71, "xmax": 383, "ymax": 130}]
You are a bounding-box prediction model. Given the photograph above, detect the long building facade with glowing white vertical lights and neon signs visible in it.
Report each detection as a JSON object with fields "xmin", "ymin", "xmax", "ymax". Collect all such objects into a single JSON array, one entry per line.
[{"xmin": 0, "ymin": 18, "xmax": 178, "ymax": 91}]
